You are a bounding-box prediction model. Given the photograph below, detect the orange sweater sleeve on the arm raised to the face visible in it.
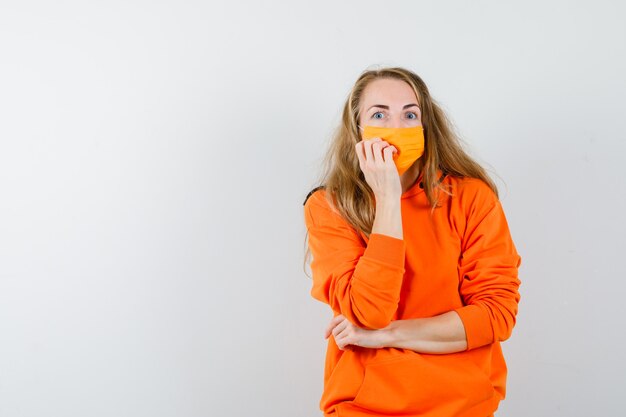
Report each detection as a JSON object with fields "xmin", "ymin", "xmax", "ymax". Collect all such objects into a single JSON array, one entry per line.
[{"xmin": 304, "ymin": 191, "xmax": 406, "ymax": 329}]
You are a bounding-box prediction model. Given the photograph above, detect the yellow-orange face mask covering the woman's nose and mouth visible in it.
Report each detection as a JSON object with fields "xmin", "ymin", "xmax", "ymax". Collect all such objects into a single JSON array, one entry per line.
[{"xmin": 363, "ymin": 126, "xmax": 424, "ymax": 175}]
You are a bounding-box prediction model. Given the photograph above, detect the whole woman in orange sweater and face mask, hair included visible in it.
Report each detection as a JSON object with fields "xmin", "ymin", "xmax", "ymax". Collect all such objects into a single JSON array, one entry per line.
[{"xmin": 304, "ymin": 68, "xmax": 521, "ymax": 417}]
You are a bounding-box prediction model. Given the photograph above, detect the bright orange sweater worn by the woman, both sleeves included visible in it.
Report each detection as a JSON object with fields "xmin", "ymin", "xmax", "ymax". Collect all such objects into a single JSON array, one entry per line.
[{"xmin": 304, "ymin": 171, "xmax": 521, "ymax": 417}]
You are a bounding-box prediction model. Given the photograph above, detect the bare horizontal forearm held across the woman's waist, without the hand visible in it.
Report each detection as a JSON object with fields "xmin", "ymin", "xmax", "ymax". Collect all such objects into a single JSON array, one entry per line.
[{"xmin": 379, "ymin": 311, "xmax": 467, "ymax": 354}]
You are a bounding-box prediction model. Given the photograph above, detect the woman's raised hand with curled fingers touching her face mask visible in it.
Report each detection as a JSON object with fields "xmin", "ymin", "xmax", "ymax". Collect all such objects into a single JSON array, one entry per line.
[{"xmin": 355, "ymin": 138, "xmax": 402, "ymax": 200}]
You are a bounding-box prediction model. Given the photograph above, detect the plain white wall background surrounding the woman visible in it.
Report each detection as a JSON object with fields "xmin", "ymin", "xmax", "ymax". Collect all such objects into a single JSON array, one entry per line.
[{"xmin": 0, "ymin": 0, "xmax": 626, "ymax": 417}]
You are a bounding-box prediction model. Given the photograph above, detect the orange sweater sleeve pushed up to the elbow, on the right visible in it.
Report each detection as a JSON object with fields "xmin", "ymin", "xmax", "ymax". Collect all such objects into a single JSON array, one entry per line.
[{"xmin": 455, "ymin": 187, "xmax": 521, "ymax": 350}]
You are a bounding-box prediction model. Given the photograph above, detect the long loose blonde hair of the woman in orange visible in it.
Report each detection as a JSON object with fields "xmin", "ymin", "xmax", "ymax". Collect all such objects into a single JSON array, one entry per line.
[{"xmin": 304, "ymin": 67, "xmax": 498, "ymax": 273}]
